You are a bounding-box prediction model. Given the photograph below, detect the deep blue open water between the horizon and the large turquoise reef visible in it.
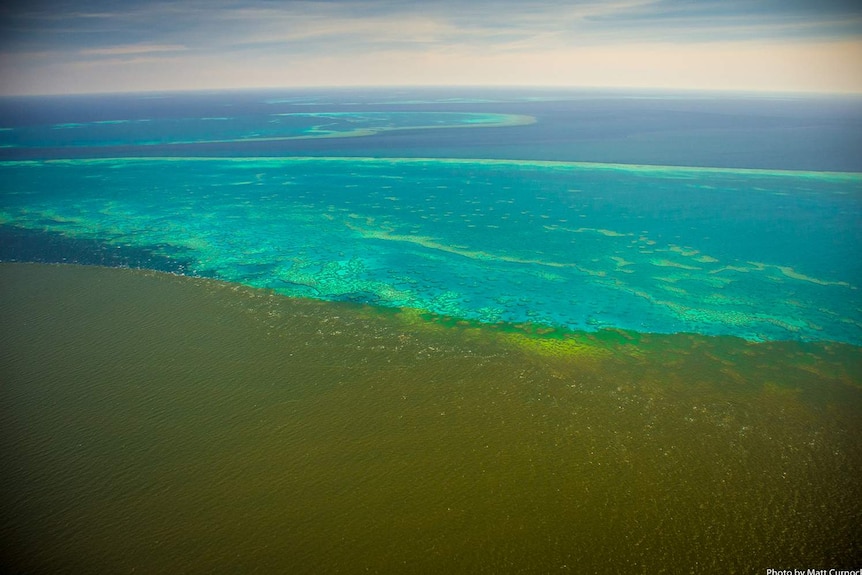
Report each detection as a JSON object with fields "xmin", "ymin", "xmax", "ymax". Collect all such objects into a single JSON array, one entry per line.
[{"xmin": 0, "ymin": 88, "xmax": 862, "ymax": 172}]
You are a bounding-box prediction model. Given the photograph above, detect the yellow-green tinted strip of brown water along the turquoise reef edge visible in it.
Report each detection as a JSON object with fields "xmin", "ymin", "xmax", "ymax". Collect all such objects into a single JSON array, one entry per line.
[{"xmin": 386, "ymin": 308, "xmax": 862, "ymax": 399}]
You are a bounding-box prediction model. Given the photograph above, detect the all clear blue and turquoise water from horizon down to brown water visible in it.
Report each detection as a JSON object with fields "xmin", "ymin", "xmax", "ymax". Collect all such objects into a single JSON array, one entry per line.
[{"xmin": 0, "ymin": 90, "xmax": 862, "ymax": 344}]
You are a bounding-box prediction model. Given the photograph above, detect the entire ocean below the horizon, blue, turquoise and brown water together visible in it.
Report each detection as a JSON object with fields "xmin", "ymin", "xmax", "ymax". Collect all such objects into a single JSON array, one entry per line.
[{"xmin": 0, "ymin": 89, "xmax": 862, "ymax": 573}]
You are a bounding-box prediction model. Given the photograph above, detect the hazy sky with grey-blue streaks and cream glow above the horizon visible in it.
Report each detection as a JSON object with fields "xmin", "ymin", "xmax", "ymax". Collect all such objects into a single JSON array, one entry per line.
[{"xmin": 0, "ymin": 0, "xmax": 862, "ymax": 95}]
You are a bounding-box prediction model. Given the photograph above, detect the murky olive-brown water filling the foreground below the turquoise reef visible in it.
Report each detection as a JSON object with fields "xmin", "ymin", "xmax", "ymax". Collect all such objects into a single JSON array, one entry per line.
[{"xmin": 0, "ymin": 264, "xmax": 862, "ymax": 573}]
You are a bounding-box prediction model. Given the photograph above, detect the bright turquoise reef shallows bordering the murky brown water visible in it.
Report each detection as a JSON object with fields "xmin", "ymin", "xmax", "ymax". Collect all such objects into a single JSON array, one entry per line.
[{"xmin": 0, "ymin": 158, "xmax": 862, "ymax": 344}]
